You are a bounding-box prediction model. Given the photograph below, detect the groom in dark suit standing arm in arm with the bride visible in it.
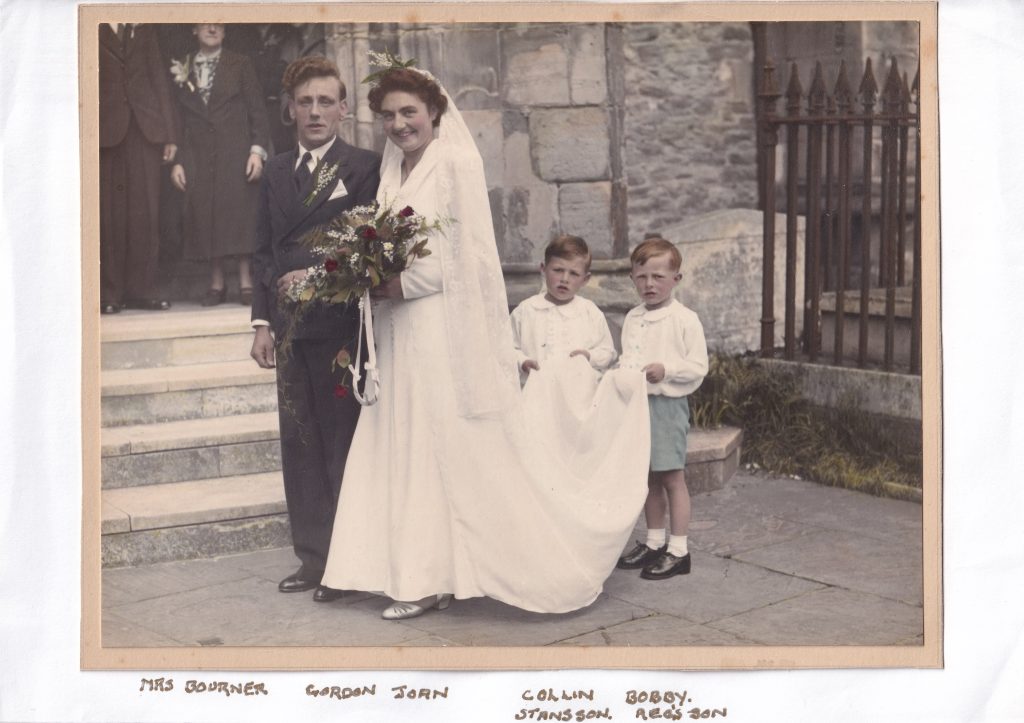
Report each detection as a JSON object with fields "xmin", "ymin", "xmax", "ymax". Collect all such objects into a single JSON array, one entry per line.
[{"xmin": 251, "ymin": 57, "xmax": 381, "ymax": 602}]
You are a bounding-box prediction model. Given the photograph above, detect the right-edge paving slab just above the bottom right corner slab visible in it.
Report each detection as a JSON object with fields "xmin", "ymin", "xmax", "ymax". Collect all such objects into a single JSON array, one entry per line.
[{"xmin": 733, "ymin": 529, "xmax": 923, "ymax": 605}]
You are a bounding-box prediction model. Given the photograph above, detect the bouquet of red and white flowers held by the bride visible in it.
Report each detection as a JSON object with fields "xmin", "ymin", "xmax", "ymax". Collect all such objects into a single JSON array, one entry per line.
[{"xmin": 288, "ymin": 203, "xmax": 443, "ymax": 304}]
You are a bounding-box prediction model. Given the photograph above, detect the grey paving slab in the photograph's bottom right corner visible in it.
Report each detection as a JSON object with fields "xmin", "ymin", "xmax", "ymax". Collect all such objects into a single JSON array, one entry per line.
[{"xmin": 710, "ymin": 588, "xmax": 924, "ymax": 645}]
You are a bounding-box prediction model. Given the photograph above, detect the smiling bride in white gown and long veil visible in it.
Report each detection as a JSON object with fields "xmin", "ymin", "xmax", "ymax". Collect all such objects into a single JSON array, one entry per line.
[{"xmin": 323, "ymin": 57, "xmax": 649, "ymax": 620}]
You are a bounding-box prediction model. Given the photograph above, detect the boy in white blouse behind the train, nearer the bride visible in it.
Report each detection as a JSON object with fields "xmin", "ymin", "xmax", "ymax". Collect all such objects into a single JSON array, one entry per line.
[{"xmin": 512, "ymin": 235, "xmax": 615, "ymax": 380}]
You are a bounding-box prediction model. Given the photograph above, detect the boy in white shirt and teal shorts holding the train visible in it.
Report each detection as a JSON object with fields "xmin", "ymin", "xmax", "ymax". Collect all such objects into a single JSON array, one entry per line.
[{"xmin": 617, "ymin": 237, "xmax": 708, "ymax": 580}]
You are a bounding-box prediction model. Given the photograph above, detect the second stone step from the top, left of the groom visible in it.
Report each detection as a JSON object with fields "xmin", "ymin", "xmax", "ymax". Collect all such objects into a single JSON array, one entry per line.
[{"xmin": 100, "ymin": 359, "xmax": 278, "ymax": 427}]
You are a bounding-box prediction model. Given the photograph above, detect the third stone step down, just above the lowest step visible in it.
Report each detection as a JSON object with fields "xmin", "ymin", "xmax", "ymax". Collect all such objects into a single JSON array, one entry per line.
[{"xmin": 100, "ymin": 412, "xmax": 281, "ymax": 490}]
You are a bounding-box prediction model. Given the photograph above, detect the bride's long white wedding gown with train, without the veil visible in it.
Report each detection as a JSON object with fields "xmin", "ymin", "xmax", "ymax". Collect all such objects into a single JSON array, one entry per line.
[{"xmin": 323, "ymin": 143, "xmax": 649, "ymax": 612}]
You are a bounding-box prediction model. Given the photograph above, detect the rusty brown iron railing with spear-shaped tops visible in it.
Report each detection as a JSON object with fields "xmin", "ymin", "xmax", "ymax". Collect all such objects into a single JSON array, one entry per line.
[{"xmin": 759, "ymin": 58, "xmax": 922, "ymax": 374}]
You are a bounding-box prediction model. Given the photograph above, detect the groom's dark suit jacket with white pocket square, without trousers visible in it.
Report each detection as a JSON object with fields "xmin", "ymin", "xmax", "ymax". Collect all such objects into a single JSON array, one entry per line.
[{"xmin": 252, "ymin": 138, "xmax": 381, "ymax": 340}]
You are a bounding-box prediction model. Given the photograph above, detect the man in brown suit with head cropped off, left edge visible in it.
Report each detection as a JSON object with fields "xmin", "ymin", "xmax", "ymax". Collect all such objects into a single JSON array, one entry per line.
[{"xmin": 99, "ymin": 23, "xmax": 177, "ymax": 313}]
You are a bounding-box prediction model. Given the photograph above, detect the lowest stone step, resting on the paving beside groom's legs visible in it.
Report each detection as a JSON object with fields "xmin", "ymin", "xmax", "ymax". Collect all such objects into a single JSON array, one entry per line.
[{"xmin": 101, "ymin": 472, "xmax": 291, "ymax": 567}]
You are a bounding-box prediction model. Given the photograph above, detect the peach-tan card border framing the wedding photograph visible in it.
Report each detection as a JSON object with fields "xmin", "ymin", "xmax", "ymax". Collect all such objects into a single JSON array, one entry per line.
[{"xmin": 78, "ymin": 2, "xmax": 943, "ymax": 671}]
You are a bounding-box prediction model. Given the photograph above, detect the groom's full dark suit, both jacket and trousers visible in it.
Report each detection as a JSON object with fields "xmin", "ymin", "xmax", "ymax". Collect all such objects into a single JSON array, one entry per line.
[{"xmin": 252, "ymin": 138, "xmax": 381, "ymax": 581}]
